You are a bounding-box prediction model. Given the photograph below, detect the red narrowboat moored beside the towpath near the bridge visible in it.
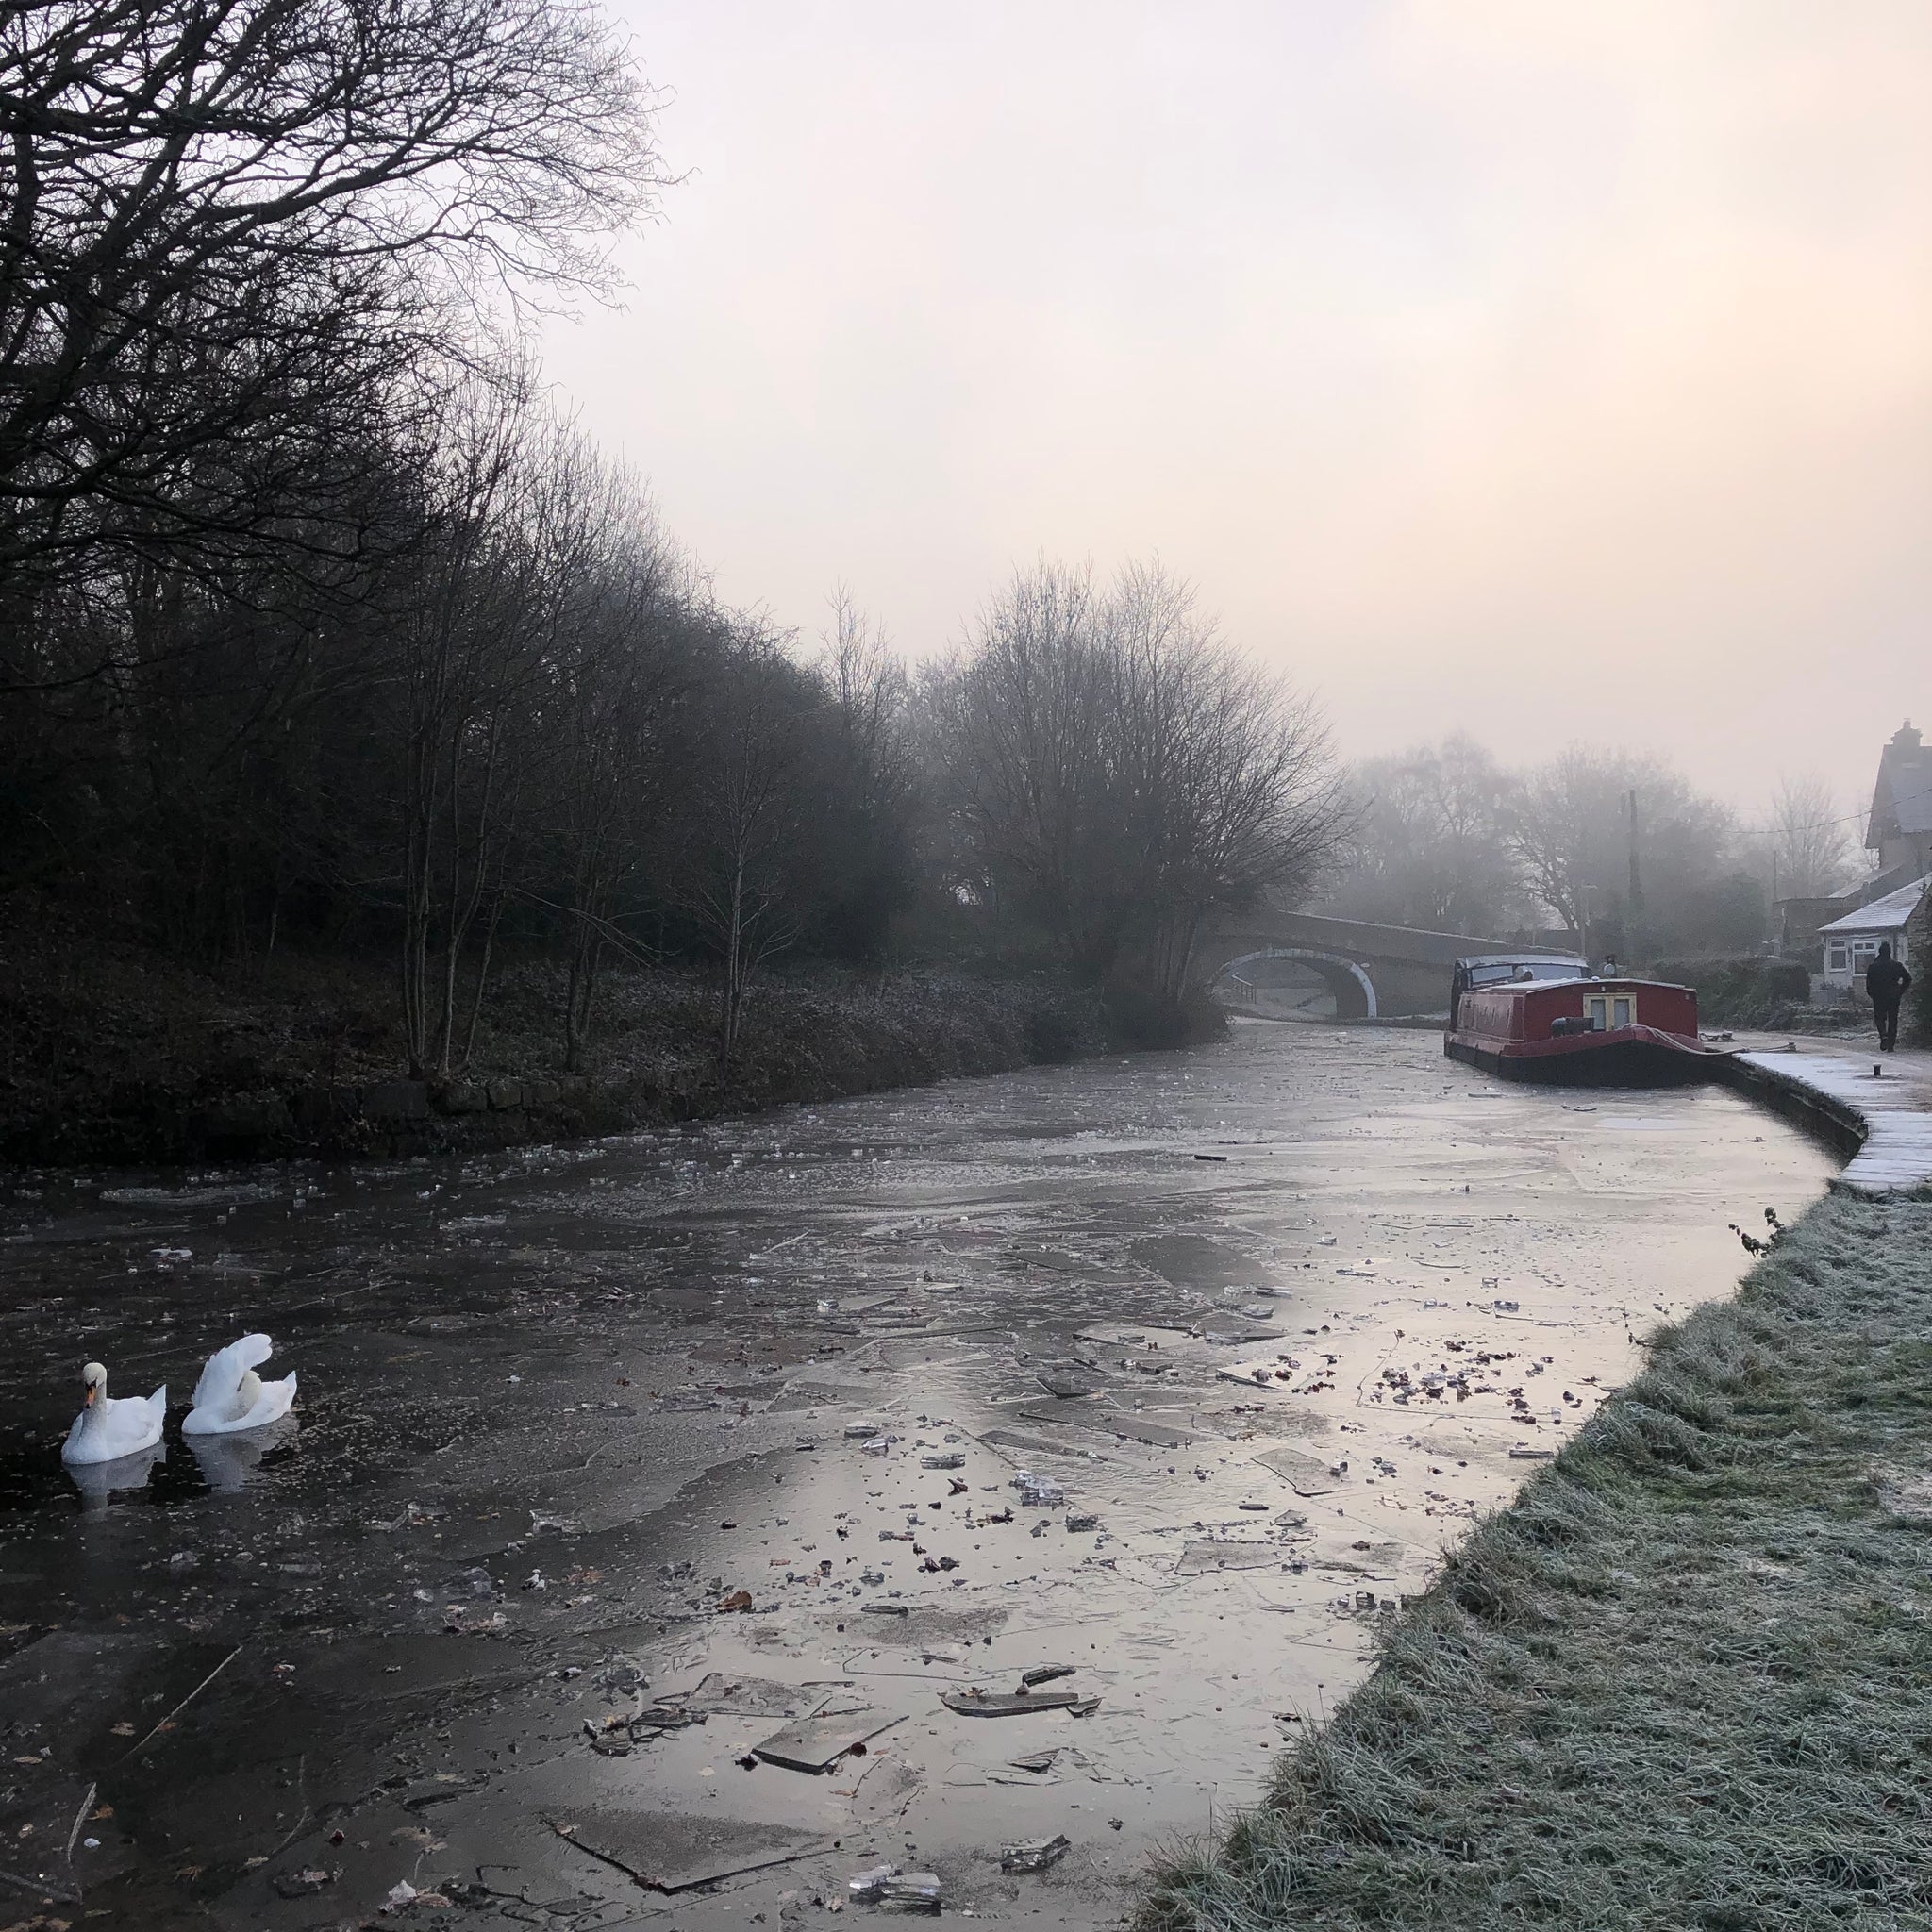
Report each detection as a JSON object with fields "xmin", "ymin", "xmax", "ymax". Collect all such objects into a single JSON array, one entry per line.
[{"xmin": 1443, "ymin": 977, "xmax": 1724, "ymax": 1086}]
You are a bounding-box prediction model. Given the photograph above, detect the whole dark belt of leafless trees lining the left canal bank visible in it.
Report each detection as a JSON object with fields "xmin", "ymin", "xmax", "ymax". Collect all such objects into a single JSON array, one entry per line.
[{"xmin": 0, "ymin": 0, "xmax": 1344, "ymax": 1073}]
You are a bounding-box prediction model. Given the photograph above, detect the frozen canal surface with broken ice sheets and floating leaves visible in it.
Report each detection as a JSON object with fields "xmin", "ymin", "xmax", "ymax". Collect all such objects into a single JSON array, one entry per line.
[{"xmin": 0, "ymin": 1024, "xmax": 1834, "ymax": 1932}]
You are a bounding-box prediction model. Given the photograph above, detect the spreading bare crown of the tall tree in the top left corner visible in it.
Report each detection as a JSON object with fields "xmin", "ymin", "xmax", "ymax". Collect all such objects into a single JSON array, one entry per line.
[{"xmin": 0, "ymin": 0, "xmax": 662, "ymax": 614}]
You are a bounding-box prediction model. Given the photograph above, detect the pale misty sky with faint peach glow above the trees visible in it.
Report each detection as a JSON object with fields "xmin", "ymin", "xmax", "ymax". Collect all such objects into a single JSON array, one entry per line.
[{"xmin": 547, "ymin": 0, "xmax": 1932, "ymax": 809}]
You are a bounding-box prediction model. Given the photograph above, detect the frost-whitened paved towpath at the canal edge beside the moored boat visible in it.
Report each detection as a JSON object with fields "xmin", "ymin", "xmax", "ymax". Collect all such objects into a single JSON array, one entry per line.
[{"xmin": 1737, "ymin": 1038, "xmax": 1932, "ymax": 1194}]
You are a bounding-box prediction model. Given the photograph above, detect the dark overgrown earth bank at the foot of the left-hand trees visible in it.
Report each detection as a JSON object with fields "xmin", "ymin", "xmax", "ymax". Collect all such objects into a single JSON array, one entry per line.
[{"xmin": 0, "ymin": 908, "xmax": 1115, "ymax": 1165}]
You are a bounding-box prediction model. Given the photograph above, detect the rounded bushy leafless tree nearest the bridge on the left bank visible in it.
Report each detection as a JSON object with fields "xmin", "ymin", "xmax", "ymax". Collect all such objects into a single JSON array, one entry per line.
[{"xmin": 937, "ymin": 564, "xmax": 1342, "ymax": 995}]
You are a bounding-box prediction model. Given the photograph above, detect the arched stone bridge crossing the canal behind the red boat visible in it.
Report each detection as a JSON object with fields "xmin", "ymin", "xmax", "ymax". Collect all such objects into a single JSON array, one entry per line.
[{"xmin": 1191, "ymin": 910, "xmax": 1561, "ymax": 1020}]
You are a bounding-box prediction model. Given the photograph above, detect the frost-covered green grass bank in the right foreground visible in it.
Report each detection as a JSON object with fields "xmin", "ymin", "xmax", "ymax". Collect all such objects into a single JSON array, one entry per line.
[{"xmin": 1140, "ymin": 1196, "xmax": 1932, "ymax": 1932}]
